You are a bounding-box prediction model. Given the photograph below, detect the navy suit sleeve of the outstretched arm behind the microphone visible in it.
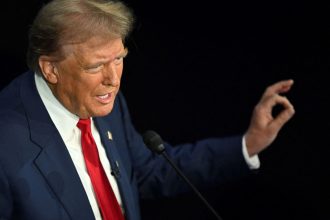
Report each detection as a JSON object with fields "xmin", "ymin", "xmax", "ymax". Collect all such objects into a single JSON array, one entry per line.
[{"xmin": 119, "ymin": 92, "xmax": 250, "ymax": 198}]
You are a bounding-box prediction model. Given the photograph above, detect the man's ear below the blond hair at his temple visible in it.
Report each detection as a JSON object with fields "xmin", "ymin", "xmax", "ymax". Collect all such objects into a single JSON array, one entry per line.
[{"xmin": 39, "ymin": 55, "xmax": 58, "ymax": 84}]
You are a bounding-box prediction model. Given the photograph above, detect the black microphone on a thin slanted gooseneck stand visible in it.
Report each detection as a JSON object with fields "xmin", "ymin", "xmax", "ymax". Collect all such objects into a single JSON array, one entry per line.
[{"xmin": 142, "ymin": 130, "xmax": 222, "ymax": 220}]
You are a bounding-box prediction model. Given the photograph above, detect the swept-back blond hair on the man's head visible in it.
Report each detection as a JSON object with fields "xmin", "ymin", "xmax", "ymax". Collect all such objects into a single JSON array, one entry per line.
[{"xmin": 27, "ymin": 0, "xmax": 134, "ymax": 73}]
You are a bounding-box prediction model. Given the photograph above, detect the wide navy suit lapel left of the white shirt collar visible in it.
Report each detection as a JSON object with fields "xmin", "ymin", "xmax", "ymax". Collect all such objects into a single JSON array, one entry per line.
[{"xmin": 21, "ymin": 73, "xmax": 94, "ymax": 219}]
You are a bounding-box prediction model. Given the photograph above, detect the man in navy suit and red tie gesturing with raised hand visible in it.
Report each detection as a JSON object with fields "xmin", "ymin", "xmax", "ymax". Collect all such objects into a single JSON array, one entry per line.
[{"xmin": 0, "ymin": 0, "xmax": 294, "ymax": 220}]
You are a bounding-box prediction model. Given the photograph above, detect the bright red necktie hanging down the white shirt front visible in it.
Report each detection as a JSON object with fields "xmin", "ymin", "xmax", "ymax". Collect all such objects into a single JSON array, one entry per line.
[{"xmin": 77, "ymin": 119, "xmax": 124, "ymax": 220}]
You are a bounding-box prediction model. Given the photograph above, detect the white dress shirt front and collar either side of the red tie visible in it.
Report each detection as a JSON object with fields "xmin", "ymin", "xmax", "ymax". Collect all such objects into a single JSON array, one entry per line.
[{"xmin": 35, "ymin": 74, "xmax": 123, "ymax": 220}]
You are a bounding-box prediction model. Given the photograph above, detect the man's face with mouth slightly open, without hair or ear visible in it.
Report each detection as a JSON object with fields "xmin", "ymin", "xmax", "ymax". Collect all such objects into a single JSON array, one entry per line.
[{"xmin": 49, "ymin": 37, "xmax": 127, "ymax": 118}]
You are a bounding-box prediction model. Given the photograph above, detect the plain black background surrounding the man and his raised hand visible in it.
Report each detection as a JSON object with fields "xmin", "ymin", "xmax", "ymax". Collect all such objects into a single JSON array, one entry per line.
[{"xmin": 0, "ymin": 0, "xmax": 330, "ymax": 220}]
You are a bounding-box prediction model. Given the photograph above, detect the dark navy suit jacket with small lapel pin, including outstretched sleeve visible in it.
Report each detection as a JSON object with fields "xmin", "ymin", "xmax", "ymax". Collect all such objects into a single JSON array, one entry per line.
[{"xmin": 0, "ymin": 72, "xmax": 249, "ymax": 220}]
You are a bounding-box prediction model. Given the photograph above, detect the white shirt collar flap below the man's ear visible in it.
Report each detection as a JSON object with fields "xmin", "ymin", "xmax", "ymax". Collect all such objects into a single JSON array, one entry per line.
[{"xmin": 34, "ymin": 73, "xmax": 79, "ymax": 142}]
